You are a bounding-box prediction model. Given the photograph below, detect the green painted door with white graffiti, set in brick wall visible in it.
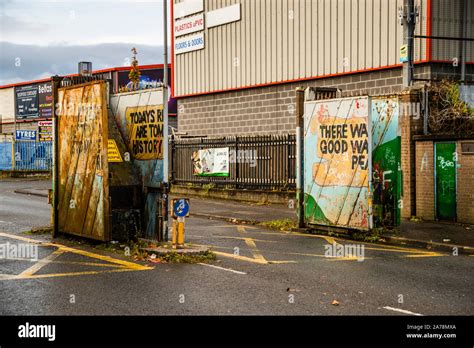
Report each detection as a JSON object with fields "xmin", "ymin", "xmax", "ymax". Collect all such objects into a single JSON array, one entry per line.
[{"xmin": 435, "ymin": 143, "xmax": 456, "ymax": 221}]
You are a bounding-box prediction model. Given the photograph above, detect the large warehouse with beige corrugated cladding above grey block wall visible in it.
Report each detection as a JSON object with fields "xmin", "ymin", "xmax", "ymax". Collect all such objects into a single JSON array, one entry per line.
[{"xmin": 172, "ymin": 0, "xmax": 474, "ymax": 136}]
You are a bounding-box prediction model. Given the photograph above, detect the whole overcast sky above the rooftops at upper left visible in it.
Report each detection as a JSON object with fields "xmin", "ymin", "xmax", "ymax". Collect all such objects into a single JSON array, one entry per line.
[{"xmin": 0, "ymin": 0, "xmax": 168, "ymax": 85}]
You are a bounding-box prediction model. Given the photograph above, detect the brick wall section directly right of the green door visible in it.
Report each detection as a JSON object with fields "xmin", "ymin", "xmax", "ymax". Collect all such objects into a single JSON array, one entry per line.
[{"xmin": 456, "ymin": 139, "xmax": 474, "ymax": 224}]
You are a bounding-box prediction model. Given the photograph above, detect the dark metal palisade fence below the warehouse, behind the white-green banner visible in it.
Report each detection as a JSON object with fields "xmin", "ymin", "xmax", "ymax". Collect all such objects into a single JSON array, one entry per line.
[{"xmin": 170, "ymin": 134, "xmax": 296, "ymax": 190}]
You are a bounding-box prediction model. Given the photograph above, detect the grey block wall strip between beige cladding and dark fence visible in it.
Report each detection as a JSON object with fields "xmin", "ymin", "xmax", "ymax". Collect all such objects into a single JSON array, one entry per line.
[{"xmin": 178, "ymin": 68, "xmax": 402, "ymax": 136}]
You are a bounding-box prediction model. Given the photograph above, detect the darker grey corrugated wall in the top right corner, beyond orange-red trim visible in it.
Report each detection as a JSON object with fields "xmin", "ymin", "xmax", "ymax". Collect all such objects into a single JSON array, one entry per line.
[{"xmin": 431, "ymin": 0, "xmax": 474, "ymax": 63}]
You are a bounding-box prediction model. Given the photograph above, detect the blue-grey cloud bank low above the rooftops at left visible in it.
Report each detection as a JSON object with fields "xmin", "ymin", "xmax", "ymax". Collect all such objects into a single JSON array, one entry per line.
[{"xmin": 0, "ymin": 41, "xmax": 163, "ymax": 85}]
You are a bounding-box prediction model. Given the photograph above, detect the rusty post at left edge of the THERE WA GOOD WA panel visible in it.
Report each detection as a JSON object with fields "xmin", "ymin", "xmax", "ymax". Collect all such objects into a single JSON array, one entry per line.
[{"xmin": 296, "ymin": 88, "xmax": 304, "ymax": 228}]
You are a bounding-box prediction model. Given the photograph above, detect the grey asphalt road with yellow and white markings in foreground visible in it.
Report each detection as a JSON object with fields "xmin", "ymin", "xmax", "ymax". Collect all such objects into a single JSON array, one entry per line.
[{"xmin": 0, "ymin": 181, "xmax": 474, "ymax": 315}]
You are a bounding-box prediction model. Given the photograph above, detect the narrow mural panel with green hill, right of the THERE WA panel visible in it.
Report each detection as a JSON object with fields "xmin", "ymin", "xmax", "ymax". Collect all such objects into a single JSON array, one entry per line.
[{"xmin": 371, "ymin": 98, "xmax": 403, "ymax": 226}]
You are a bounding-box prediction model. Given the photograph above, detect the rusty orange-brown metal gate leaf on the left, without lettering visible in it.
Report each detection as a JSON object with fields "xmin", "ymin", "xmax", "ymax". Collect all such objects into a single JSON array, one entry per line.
[{"xmin": 56, "ymin": 81, "xmax": 110, "ymax": 241}]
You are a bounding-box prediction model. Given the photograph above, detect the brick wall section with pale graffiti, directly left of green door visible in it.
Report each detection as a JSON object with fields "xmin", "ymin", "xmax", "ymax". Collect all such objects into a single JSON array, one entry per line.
[{"xmin": 415, "ymin": 141, "xmax": 435, "ymax": 220}]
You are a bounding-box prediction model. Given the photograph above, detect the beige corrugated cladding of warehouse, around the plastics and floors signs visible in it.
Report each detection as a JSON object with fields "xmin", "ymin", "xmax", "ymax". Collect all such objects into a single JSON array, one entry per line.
[{"xmin": 175, "ymin": 0, "xmax": 427, "ymax": 96}]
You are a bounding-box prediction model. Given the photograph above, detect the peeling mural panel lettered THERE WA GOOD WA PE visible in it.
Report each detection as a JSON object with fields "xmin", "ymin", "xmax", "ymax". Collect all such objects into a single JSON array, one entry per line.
[{"xmin": 304, "ymin": 97, "xmax": 370, "ymax": 230}]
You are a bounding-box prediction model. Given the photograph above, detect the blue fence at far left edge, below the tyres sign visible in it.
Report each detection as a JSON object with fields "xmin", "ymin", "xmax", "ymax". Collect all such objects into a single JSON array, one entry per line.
[{"xmin": 0, "ymin": 141, "xmax": 53, "ymax": 171}]
